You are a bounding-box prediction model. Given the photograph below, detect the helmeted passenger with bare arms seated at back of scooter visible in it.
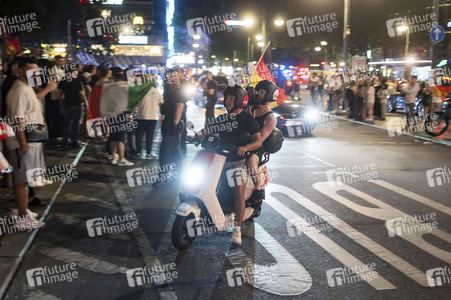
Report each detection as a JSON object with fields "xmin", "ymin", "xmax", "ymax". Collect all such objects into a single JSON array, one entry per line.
[{"xmin": 247, "ymin": 80, "xmax": 279, "ymax": 208}]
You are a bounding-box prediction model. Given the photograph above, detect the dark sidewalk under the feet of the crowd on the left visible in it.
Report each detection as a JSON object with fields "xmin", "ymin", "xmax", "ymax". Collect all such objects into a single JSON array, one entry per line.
[{"xmin": 0, "ymin": 142, "xmax": 87, "ymax": 299}]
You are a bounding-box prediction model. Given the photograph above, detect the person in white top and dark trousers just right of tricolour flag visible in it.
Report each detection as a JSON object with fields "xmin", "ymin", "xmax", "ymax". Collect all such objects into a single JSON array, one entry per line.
[{"xmin": 136, "ymin": 79, "xmax": 163, "ymax": 160}]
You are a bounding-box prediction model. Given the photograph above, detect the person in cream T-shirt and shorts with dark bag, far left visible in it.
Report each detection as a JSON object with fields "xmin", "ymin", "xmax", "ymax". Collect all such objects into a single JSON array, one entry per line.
[{"xmin": 5, "ymin": 57, "xmax": 45, "ymax": 229}]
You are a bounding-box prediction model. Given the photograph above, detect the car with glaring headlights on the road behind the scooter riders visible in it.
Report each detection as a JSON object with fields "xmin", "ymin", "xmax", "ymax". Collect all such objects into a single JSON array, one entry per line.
[{"xmin": 272, "ymin": 100, "xmax": 319, "ymax": 136}]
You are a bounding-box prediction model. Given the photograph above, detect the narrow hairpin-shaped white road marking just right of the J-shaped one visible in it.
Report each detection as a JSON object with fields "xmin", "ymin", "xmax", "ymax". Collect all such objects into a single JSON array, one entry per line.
[{"xmin": 265, "ymin": 183, "xmax": 398, "ymax": 290}]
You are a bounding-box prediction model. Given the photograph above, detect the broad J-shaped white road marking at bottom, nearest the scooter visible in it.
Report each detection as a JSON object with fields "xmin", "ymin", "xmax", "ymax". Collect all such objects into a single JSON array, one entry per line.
[{"xmin": 227, "ymin": 223, "xmax": 312, "ymax": 296}]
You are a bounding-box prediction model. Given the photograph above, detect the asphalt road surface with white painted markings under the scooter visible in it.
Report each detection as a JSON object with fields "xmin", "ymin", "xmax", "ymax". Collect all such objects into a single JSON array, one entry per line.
[{"xmin": 1, "ymin": 96, "xmax": 451, "ymax": 299}]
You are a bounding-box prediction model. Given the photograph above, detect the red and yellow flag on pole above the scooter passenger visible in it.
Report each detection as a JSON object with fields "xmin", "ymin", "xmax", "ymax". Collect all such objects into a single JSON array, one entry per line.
[{"xmin": 250, "ymin": 42, "xmax": 288, "ymax": 108}]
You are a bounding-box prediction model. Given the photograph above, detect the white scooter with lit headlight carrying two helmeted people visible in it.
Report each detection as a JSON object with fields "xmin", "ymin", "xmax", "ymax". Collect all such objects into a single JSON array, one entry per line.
[{"xmin": 172, "ymin": 122, "xmax": 269, "ymax": 250}]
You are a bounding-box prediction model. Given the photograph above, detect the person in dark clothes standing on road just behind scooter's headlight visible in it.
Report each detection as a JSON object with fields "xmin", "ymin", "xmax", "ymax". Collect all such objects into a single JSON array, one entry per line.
[{"xmin": 154, "ymin": 68, "xmax": 187, "ymax": 187}]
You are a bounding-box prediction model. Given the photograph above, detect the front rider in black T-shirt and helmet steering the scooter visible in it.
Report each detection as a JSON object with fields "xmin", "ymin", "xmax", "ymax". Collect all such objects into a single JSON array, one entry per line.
[{"xmin": 192, "ymin": 85, "xmax": 262, "ymax": 244}]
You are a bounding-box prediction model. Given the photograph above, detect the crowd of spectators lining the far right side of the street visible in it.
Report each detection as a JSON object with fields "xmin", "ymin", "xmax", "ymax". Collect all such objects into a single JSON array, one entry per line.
[{"xmin": 304, "ymin": 73, "xmax": 443, "ymax": 128}]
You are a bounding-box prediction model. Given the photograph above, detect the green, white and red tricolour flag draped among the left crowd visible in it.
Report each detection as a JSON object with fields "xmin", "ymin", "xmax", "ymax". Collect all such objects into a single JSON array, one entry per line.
[{"xmin": 88, "ymin": 81, "xmax": 152, "ymax": 119}]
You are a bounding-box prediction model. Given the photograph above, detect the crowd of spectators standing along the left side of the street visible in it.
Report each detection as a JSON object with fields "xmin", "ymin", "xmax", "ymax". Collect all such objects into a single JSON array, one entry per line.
[{"xmin": 0, "ymin": 56, "xmax": 187, "ymax": 230}]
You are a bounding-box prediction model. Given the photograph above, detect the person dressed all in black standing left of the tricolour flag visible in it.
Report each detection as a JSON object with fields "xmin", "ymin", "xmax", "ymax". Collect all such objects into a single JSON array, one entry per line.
[{"xmin": 59, "ymin": 65, "xmax": 86, "ymax": 149}]
